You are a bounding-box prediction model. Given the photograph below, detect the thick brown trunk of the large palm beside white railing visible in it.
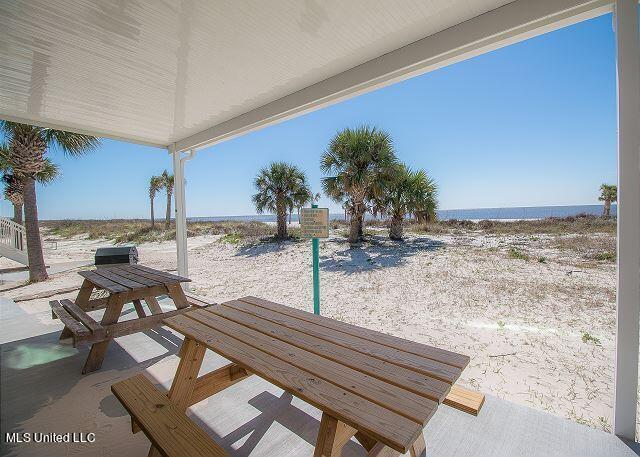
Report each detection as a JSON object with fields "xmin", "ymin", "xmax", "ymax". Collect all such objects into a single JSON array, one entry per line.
[{"xmin": 24, "ymin": 177, "xmax": 49, "ymax": 282}]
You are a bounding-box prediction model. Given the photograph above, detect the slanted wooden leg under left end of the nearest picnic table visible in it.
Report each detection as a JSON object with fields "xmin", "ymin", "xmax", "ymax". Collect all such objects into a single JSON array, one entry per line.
[{"xmin": 149, "ymin": 337, "xmax": 207, "ymax": 457}]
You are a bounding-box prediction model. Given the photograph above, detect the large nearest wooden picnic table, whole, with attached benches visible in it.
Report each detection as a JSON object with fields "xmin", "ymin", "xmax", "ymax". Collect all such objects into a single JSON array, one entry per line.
[{"xmin": 112, "ymin": 297, "xmax": 484, "ymax": 457}]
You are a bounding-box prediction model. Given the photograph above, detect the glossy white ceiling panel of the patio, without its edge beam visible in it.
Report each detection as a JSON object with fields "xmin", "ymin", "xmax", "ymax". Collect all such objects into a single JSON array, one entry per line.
[{"xmin": 0, "ymin": 0, "xmax": 511, "ymax": 146}]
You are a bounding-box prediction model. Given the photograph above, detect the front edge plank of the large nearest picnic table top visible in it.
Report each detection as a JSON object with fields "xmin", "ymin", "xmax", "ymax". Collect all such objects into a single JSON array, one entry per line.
[{"xmin": 165, "ymin": 313, "xmax": 422, "ymax": 452}]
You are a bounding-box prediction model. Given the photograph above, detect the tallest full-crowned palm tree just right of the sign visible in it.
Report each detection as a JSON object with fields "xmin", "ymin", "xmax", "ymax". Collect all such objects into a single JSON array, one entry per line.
[{"xmin": 320, "ymin": 126, "xmax": 397, "ymax": 245}]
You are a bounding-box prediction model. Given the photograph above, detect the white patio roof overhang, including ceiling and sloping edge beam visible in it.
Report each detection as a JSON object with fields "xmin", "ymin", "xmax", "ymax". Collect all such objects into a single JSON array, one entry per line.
[{"xmin": 0, "ymin": 0, "xmax": 612, "ymax": 150}]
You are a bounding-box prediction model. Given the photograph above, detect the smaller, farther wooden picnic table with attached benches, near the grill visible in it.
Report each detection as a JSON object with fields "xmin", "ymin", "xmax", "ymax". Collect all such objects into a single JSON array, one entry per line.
[{"xmin": 49, "ymin": 264, "xmax": 208, "ymax": 374}]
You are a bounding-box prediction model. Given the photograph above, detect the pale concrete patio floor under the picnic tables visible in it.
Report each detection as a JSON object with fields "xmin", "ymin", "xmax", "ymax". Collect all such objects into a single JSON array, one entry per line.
[{"xmin": 0, "ymin": 299, "xmax": 636, "ymax": 457}]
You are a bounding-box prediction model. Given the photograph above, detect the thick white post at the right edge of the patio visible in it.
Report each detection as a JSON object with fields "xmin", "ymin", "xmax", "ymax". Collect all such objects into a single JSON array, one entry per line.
[{"xmin": 613, "ymin": 0, "xmax": 640, "ymax": 440}]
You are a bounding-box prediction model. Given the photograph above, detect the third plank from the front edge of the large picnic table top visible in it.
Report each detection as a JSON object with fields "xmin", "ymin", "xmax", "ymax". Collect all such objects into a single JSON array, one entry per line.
[{"xmin": 200, "ymin": 305, "xmax": 451, "ymax": 403}]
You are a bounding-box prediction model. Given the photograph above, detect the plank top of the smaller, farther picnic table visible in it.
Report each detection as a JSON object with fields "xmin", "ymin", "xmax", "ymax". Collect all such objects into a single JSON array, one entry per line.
[{"xmin": 78, "ymin": 264, "xmax": 191, "ymax": 293}]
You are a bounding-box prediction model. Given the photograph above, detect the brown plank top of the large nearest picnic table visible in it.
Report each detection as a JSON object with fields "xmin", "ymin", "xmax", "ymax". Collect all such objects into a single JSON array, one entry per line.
[{"xmin": 164, "ymin": 297, "xmax": 469, "ymax": 452}]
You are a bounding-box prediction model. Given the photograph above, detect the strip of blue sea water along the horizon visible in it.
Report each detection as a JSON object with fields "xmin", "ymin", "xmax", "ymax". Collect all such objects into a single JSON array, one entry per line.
[{"xmin": 189, "ymin": 205, "xmax": 617, "ymax": 222}]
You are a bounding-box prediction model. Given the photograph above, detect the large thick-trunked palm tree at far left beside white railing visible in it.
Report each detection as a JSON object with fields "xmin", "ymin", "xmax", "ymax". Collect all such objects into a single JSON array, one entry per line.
[{"xmin": 0, "ymin": 121, "xmax": 100, "ymax": 282}]
